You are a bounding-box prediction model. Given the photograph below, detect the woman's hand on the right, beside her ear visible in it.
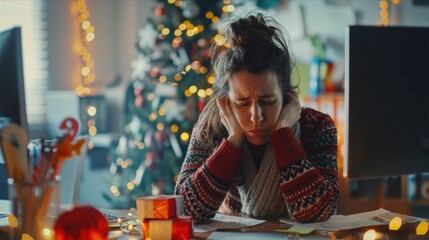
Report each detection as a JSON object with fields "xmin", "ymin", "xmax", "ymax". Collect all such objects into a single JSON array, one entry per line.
[{"xmin": 275, "ymin": 90, "xmax": 301, "ymax": 130}]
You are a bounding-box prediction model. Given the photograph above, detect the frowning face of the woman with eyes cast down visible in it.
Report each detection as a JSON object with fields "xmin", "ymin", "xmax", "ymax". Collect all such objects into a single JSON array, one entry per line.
[{"xmin": 229, "ymin": 71, "xmax": 283, "ymax": 145}]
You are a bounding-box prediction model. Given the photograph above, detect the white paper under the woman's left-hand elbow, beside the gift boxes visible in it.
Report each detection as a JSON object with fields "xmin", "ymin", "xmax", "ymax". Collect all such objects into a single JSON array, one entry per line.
[{"xmin": 194, "ymin": 214, "xmax": 265, "ymax": 232}]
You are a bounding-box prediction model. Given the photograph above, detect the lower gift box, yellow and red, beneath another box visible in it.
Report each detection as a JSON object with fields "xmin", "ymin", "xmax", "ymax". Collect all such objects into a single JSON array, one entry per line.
[{"xmin": 143, "ymin": 216, "xmax": 192, "ymax": 240}]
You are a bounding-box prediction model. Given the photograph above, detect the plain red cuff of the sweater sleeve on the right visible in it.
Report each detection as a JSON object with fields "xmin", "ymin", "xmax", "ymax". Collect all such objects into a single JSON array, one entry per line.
[{"xmin": 271, "ymin": 128, "xmax": 307, "ymax": 170}]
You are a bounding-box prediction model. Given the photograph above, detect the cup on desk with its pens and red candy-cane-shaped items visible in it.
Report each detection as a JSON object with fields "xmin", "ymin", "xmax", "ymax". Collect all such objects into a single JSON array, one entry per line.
[{"xmin": 0, "ymin": 118, "xmax": 87, "ymax": 240}]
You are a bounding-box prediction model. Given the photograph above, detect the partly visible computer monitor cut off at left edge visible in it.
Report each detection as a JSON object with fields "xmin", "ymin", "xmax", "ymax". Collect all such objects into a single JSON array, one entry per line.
[{"xmin": 0, "ymin": 27, "xmax": 27, "ymax": 199}]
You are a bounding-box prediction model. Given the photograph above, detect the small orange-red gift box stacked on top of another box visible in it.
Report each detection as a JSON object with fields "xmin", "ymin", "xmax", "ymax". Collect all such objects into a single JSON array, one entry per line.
[{"xmin": 136, "ymin": 195, "xmax": 183, "ymax": 220}]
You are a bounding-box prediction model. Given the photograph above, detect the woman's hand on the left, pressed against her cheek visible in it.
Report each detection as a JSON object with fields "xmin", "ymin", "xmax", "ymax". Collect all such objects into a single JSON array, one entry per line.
[{"xmin": 216, "ymin": 96, "xmax": 245, "ymax": 148}]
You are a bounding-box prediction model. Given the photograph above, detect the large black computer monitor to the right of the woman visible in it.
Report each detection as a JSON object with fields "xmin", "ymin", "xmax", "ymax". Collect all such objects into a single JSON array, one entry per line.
[{"xmin": 343, "ymin": 26, "xmax": 429, "ymax": 179}]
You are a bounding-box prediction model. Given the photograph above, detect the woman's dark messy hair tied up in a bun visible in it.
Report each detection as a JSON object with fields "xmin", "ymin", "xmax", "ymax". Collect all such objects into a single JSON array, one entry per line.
[{"xmin": 193, "ymin": 13, "xmax": 295, "ymax": 147}]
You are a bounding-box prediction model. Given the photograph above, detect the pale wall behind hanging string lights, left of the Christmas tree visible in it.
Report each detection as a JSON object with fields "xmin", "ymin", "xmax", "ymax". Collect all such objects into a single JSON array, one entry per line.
[{"xmin": 47, "ymin": 0, "xmax": 153, "ymax": 131}]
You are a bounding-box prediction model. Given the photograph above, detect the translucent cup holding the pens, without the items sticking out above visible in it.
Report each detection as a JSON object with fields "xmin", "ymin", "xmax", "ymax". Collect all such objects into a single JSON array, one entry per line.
[{"xmin": 8, "ymin": 179, "xmax": 61, "ymax": 240}]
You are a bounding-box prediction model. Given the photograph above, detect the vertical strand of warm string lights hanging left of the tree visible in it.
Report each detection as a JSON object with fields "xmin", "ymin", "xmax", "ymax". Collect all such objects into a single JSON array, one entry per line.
[{"xmin": 71, "ymin": 0, "xmax": 97, "ymax": 138}]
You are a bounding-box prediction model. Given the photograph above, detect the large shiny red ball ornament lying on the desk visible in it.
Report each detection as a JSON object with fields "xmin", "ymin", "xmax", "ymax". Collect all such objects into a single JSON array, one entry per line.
[{"xmin": 54, "ymin": 206, "xmax": 109, "ymax": 240}]
